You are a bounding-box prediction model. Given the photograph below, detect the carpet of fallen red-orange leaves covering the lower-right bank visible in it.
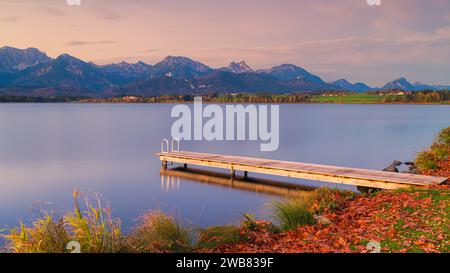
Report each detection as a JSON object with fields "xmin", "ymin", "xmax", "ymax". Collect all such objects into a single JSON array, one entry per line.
[{"xmin": 216, "ymin": 185, "xmax": 450, "ymax": 253}]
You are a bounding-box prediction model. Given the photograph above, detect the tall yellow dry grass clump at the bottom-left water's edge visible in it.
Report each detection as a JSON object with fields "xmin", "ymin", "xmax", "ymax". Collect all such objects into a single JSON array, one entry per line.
[{"xmin": 4, "ymin": 191, "xmax": 125, "ymax": 253}]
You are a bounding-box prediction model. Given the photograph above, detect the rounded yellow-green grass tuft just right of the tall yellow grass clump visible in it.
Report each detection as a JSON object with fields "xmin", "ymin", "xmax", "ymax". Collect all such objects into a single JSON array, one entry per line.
[{"xmin": 128, "ymin": 210, "xmax": 194, "ymax": 252}]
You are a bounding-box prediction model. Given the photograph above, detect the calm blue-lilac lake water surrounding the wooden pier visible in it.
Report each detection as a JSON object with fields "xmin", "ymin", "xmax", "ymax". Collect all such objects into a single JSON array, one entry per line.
[{"xmin": 0, "ymin": 104, "xmax": 450, "ymax": 230}]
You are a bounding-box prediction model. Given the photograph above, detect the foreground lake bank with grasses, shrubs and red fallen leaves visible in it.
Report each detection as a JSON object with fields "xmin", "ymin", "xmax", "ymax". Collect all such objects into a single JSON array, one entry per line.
[{"xmin": 0, "ymin": 127, "xmax": 450, "ymax": 253}]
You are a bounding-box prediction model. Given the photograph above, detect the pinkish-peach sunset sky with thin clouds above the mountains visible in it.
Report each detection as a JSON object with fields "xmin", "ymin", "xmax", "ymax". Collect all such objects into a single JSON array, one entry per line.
[{"xmin": 0, "ymin": 0, "xmax": 450, "ymax": 86}]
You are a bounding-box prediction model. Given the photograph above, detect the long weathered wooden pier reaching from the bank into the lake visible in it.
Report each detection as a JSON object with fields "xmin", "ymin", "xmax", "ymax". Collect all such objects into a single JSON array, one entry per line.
[{"xmin": 156, "ymin": 151, "xmax": 447, "ymax": 189}]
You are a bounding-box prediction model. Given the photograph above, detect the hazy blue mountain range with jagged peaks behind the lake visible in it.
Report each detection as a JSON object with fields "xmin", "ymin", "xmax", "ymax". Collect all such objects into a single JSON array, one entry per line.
[{"xmin": 0, "ymin": 47, "xmax": 450, "ymax": 97}]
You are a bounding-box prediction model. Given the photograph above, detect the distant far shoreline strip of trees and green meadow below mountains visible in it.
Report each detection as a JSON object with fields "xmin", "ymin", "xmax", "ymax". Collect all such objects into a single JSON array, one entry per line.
[{"xmin": 0, "ymin": 90, "xmax": 450, "ymax": 105}]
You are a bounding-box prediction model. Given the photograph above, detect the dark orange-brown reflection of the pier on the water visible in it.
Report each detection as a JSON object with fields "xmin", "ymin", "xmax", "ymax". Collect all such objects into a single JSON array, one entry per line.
[{"xmin": 160, "ymin": 167, "xmax": 315, "ymax": 197}]
